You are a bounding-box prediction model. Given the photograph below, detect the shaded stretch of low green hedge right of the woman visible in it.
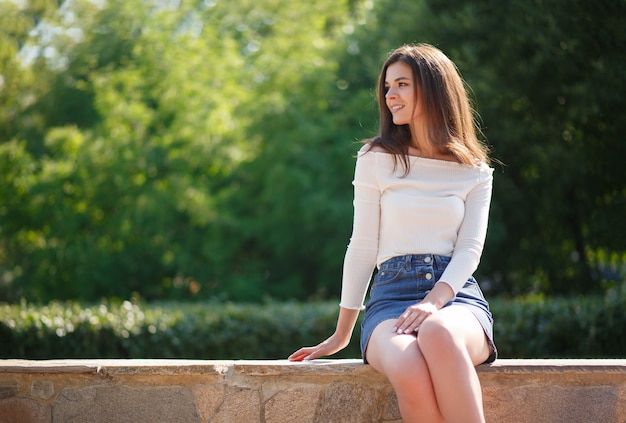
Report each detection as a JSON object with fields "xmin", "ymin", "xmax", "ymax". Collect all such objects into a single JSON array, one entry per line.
[{"xmin": 491, "ymin": 290, "xmax": 626, "ymax": 358}]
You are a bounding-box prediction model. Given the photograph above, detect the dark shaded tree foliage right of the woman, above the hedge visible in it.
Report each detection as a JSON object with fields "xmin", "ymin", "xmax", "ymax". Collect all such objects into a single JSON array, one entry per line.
[{"xmin": 420, "ymin": 0, "xmax": 626, "ymax": 293}]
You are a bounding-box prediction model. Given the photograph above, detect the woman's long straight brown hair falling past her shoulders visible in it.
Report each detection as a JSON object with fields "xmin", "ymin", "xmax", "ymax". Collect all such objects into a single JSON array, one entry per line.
[{"xmin": 369, "ymin": 44, "xmax": 489, "ymax": 173}]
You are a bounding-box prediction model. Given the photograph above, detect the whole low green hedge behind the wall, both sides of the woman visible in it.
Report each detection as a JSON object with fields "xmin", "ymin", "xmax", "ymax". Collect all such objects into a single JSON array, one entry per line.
[{"xmin": 0, "ymin": 294, "xmax": 626, "ymax": 359}]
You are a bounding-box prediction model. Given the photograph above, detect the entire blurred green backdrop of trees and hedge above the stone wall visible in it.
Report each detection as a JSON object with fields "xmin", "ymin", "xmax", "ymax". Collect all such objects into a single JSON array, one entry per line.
[{"xmin": 0, "ymin": 0, "xmax": 626, "ymax": 358}]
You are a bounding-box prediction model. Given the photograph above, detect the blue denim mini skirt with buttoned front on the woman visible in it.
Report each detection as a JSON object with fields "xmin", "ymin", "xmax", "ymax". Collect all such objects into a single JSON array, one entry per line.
[{"xmin": 361, "ymin": 254, "xmax": 498, "ymax": 363}]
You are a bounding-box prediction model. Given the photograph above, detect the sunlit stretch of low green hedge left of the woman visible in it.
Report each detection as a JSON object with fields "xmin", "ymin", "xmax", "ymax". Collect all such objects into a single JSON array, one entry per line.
[{"xmin": 0, "ymin": 301, "xmax": 359, "ymax": 359}]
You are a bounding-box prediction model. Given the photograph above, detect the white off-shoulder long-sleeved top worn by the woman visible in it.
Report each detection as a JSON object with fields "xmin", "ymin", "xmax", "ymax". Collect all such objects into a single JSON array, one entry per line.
[{"xmin": 340, "ymin": 146, "xmax": 493, "ymax": 309}]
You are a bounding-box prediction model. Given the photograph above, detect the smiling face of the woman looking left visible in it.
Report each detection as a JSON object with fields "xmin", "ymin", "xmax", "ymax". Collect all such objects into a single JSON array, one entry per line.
[{"xmin": 385, "ymin": 62, "xmax": 422, "ymax": 125}]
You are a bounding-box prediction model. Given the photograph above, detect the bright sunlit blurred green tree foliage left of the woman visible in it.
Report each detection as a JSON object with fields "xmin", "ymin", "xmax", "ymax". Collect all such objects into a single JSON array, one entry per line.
[{"xmin": 0, "ymin": 0, "xmax": 368, "ymax": 300}]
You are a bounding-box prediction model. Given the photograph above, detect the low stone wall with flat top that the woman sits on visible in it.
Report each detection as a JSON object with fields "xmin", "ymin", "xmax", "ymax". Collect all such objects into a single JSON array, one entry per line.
[{"xmin": 0, "ymin": 360, "xmax": 626, "ymax": 423}]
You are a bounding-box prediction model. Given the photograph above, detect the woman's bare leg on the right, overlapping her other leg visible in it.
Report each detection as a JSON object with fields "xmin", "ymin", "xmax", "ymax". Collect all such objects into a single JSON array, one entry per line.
[{"xmin": 417, "ymin": 306, "xmax": 489, "ymax": 423}]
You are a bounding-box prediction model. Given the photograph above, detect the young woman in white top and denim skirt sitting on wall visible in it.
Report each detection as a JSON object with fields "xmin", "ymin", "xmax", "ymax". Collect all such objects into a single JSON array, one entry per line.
[{"xmin": 289, "ymin": 44, "xmax": 496, "ymax": 423}]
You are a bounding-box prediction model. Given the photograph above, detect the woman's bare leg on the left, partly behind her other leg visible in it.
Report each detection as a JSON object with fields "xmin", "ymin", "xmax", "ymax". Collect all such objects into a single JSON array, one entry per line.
[{"xmin": 366, "ymin": 319, "xmax": 443, "ymax": 423}]
